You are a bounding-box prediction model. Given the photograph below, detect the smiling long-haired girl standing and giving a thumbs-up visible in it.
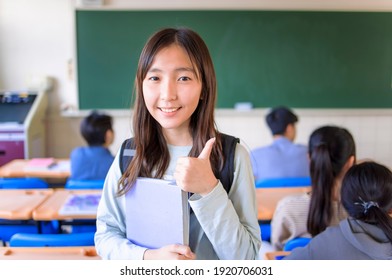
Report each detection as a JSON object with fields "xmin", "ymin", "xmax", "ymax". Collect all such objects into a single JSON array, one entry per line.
[{"xmin": 95, "ymin": 28, "xmax": 261, "ymax": 260}]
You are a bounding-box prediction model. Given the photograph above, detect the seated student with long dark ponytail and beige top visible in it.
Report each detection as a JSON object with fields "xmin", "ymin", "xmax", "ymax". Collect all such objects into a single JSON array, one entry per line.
[{"xmin": 271, "ymin": 126, "xmax": 355, "ymax": 250}]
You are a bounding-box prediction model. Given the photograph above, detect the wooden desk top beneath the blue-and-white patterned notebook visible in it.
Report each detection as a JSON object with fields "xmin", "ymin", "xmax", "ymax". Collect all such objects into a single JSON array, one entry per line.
[{"xmin": 33, "ymin": 189, "xmax": 102, "ymax": 221}]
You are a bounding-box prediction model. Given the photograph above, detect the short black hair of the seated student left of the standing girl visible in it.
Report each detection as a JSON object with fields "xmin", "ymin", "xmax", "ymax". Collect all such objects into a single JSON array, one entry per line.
[{"xmin": 80, "ymin": 111, "xmax": 113, "ymax": 146}]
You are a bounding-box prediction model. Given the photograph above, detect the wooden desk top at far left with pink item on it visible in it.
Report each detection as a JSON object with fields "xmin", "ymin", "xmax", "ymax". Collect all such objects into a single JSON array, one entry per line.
[{"xmin": 0, "ymin": 159, "xmax": 71, "ymax": 179}]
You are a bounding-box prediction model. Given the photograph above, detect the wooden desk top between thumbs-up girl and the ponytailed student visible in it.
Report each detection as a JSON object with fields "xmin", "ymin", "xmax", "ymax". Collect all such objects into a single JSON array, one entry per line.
[{"xmin": 256, "ymin": 186, "xmax": 311, "ymax": 221}]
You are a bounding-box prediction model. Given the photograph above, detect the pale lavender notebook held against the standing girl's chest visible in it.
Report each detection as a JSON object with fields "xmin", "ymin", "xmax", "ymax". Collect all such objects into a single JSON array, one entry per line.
[{"xmin": 125, "ymin": 178, "xmax": 189, "ymax": 249}]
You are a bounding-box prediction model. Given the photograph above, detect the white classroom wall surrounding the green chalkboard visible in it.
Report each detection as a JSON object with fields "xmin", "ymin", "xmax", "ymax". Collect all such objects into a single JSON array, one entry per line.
[{"xmin": 0, "ymin": 0, "xmax": 392, "ymax": 166}]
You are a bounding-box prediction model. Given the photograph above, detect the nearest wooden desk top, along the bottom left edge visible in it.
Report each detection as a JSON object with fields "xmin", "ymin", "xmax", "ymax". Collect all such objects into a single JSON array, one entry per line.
[{"xmin": 0, "ymin": 246, "xmax": 101, "ymax": 260}]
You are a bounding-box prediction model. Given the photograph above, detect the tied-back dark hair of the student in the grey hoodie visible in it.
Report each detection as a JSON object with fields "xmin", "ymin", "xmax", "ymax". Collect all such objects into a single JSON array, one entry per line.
[{"xmin": 341, "ymin": 162, "xmax": 392, "ymax": 242}]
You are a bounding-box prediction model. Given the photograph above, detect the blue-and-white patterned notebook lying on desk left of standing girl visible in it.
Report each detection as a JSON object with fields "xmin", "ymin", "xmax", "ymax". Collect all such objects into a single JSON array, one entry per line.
[{"xmin": 59, "ymin": 193, "xmax": 101, "ymax": 216}]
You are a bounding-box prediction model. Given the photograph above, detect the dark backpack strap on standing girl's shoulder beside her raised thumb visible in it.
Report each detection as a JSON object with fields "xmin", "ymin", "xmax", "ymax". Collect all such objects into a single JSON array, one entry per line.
[{"xmin": 218, "ymin": 133, "xmax": 240, "ymax": 193}]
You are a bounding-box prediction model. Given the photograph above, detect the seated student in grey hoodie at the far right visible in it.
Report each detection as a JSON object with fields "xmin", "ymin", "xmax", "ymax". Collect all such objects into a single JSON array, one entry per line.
[{"xmin": 285, "ymin": 162, "xmax": 392, "ymax": 260}]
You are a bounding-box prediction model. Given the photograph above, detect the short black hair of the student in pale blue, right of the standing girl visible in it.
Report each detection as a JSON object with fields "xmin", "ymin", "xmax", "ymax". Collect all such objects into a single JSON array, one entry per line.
[{"xmin": 265, "ymin": 106, "xmax": 298, "ymax": 135}]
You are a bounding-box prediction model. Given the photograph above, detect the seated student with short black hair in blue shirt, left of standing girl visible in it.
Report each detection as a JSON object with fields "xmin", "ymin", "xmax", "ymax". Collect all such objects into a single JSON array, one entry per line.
[{"xmin": 70, "ymin": 111, "xmax": 114, "ymax": 180}]
